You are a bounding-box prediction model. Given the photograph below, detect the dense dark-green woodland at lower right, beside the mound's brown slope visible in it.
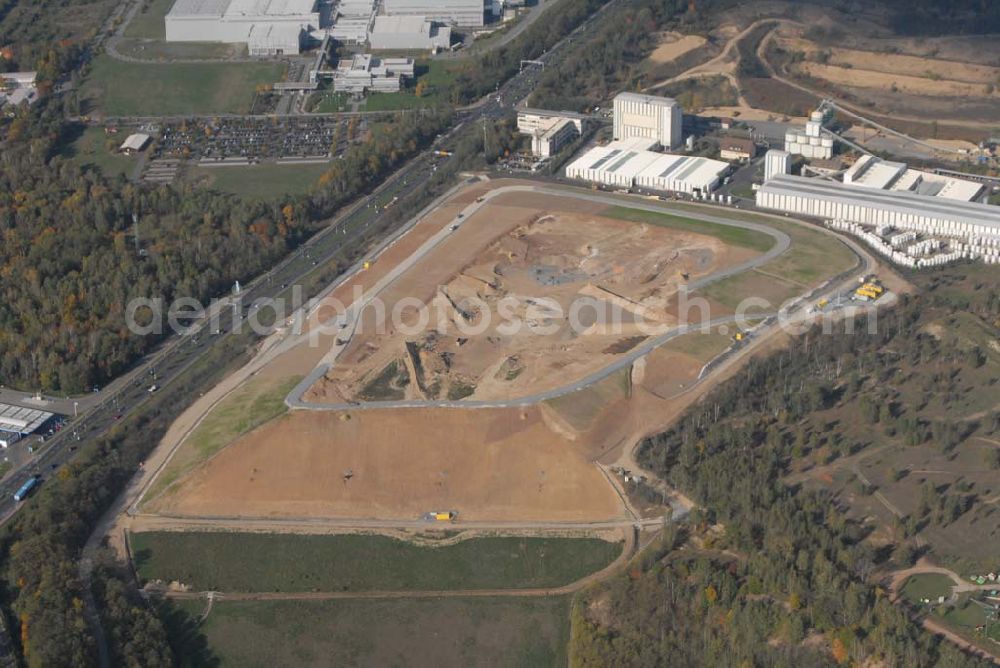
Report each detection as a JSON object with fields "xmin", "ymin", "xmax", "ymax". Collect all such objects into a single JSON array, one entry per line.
[{"xmin": 574, "ymin": 269, "xmax": 1000, "ymax": 666}]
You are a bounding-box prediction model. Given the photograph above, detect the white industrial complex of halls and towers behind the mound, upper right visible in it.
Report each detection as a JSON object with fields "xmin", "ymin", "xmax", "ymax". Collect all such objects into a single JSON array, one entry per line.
[{"xmin": 556, "ymin": 93, "xmax": 1000, "ymax": 268}]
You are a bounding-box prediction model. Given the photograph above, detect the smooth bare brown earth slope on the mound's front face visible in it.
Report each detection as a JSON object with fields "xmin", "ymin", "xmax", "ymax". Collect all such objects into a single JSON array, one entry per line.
[{"xmin": 147, "ymin": 408, "xmax": 622, "ymax": 521}]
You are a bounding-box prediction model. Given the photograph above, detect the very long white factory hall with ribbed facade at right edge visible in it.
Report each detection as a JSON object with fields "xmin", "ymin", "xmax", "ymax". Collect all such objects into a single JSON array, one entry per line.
[{"xmin": 757, "ymin": 175, "xmax": 1000, "ymax": 240}]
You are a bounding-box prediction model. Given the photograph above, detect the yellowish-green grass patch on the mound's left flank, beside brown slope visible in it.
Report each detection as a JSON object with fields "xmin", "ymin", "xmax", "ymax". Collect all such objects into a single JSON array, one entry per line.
[{"xmin": 145, "ymin": 376, "xmax": 301, "ymax": 499}]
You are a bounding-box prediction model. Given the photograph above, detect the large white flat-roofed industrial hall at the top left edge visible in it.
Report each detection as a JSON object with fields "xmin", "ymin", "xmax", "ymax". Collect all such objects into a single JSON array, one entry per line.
[{"xmin": 165, "ymin": 0, "xmax": 320, "ymax": 56}]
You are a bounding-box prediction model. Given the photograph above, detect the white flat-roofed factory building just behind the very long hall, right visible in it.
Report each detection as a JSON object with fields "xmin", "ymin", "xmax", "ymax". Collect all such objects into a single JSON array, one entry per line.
[{"xmin": 844, "ymin": 155, "xmax": 988, "ymax": 202}]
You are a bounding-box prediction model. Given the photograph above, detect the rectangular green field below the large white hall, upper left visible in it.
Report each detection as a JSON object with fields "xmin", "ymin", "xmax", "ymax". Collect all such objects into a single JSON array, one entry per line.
[{"xmin": 82, "ymin": 55, "xmax": 284, "ymax": 116}]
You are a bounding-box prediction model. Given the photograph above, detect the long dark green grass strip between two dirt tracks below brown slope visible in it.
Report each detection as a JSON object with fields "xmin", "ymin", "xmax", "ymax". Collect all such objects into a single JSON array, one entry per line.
[{"xmin": 132, "ymin": 532, "xmax": 622, "ymax": 592}]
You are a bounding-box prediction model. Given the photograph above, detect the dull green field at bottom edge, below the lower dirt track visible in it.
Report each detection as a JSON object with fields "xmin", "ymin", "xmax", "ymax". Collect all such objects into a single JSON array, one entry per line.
[{"xmin": 174, "ymin": 597, "xmax": 569, "ymax": 668}]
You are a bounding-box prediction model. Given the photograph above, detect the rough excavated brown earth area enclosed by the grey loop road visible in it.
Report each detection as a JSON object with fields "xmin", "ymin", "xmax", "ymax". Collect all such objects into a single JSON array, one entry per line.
[{"xmin": 305, "ymin": 194, "xmax": 750, "ymax": 403}]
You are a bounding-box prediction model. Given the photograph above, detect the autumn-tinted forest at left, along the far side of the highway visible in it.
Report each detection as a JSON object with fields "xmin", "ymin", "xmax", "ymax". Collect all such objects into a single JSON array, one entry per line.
[{"xmin": 0, "ymin": 99, "xmax": 450, "ymax": 392}]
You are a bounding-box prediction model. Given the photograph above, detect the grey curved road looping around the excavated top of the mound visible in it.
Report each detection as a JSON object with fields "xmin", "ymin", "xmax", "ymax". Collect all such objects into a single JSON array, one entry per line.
[{"xmin": 285, "ymin": 186, "xmax": 791, "ymax": 411}]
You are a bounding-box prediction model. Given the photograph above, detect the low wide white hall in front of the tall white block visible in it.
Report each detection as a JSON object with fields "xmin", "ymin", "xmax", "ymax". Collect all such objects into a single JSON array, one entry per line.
[{"xmin": 566, "ymin": 138, "xmax": 729, "ymax": 196}]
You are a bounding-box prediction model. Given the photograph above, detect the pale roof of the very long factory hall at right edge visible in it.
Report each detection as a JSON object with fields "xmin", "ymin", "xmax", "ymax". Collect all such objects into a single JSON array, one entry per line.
[{"xmin": 757, "ymin": 174, "xmax": 1000, "ymax": 235}]
